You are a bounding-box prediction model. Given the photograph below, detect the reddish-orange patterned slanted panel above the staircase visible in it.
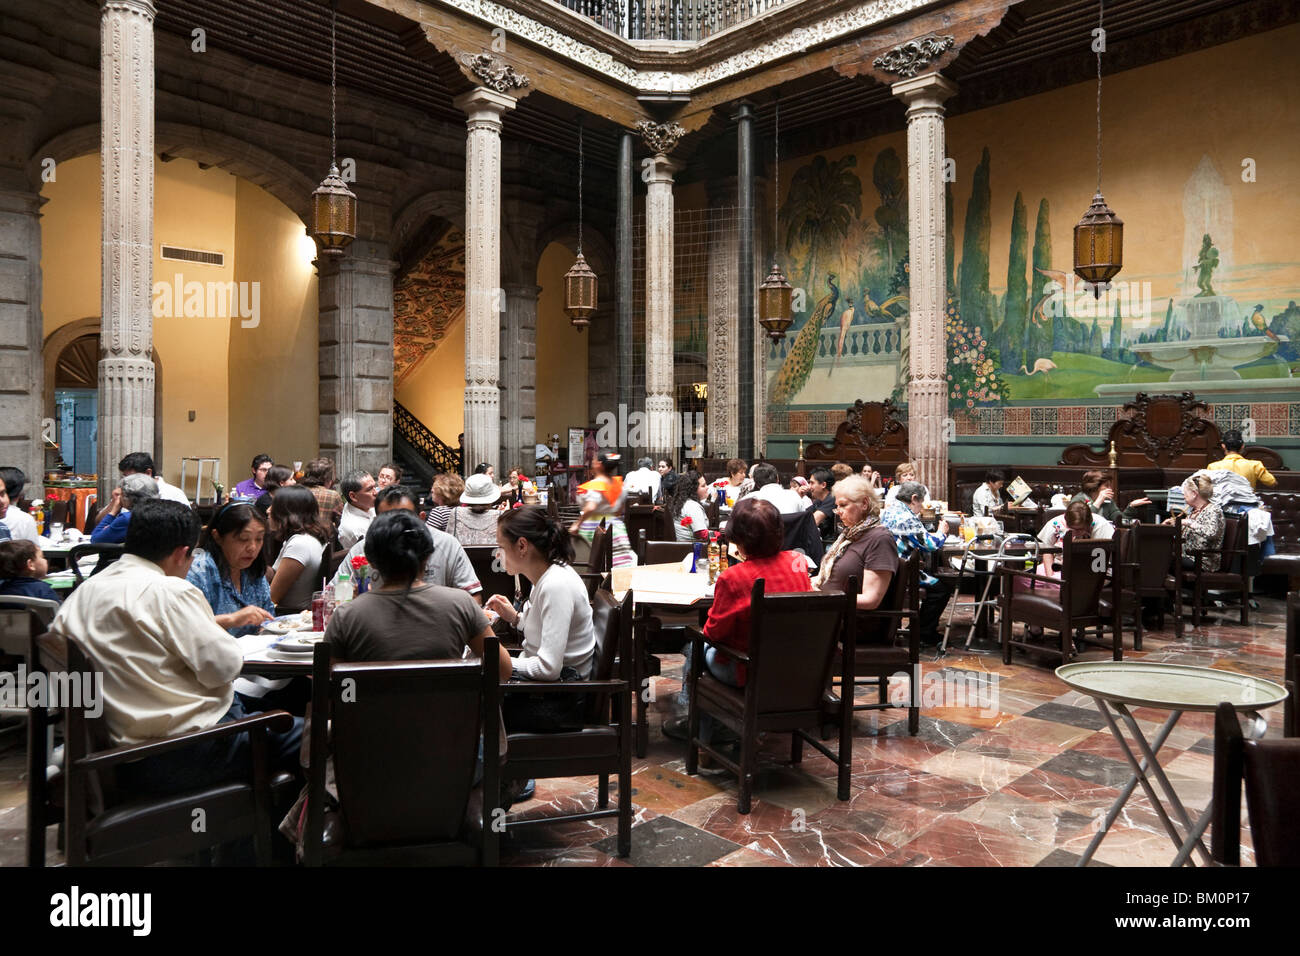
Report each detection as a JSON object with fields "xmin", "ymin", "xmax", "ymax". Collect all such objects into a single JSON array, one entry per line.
[{"xmin": 393, "ymin": 228, "xmax": 465, "ymax": 385}]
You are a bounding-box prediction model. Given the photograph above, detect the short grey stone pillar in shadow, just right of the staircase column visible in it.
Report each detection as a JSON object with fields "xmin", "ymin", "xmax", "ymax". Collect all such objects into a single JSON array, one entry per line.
[{"xmin": 497, "ymin": 285, "xmax": 542, "ymax": 479}]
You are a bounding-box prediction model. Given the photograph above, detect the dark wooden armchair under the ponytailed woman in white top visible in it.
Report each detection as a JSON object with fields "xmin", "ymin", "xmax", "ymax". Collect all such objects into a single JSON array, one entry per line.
[{"xmin": 496, "ymin": 591, "xmax": 636, "ymax": 856}]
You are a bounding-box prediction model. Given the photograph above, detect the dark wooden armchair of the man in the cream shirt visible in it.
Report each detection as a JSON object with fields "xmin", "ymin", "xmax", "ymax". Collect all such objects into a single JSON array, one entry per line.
[{"xmin": 64, "ymin": 641, "xmax": 298, "ymax": 866}]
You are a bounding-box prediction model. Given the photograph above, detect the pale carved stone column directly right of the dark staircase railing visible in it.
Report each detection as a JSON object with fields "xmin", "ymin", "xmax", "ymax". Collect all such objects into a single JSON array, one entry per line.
[{"xmin": 455, "ymin": 87, "xmax": 514, "ymax": 472}]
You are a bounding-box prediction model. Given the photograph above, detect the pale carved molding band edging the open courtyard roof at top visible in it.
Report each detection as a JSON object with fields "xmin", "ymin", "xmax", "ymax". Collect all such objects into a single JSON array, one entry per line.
[{"xmin": 421, "ymin": 0, "xmax": 932, "ymax": 94}]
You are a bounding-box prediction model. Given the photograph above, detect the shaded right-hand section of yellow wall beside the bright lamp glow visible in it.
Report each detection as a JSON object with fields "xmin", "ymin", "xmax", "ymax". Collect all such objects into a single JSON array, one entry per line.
[{"xmin": 229, "ymin": 179, "xmax": 319, "ymax": 480}]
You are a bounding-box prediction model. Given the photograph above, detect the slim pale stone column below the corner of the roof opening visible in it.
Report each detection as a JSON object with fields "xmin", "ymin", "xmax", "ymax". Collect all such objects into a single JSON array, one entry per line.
[{"xmin": 646, "ymin": 152, "xmax": 679, "ymax": 458}]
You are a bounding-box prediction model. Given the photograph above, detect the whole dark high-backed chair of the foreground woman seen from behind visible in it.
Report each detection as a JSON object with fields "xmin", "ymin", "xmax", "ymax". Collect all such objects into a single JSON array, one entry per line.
[{"xmin": 303, "ymin": 637, "xmax": 501, "ymax": 866}]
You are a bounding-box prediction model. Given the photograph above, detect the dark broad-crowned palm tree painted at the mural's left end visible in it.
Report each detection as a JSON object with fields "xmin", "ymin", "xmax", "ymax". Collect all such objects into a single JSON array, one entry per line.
[{"xmin": 781, "ymin": 152, "xmax": 862, "ymax": 299}]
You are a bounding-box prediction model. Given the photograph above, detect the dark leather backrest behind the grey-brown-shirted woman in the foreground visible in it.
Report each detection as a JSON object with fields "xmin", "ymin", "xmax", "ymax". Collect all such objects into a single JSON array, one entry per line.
[{"xmin": 312, "ymin": 640, "xmax": 499, "ymax": 847}]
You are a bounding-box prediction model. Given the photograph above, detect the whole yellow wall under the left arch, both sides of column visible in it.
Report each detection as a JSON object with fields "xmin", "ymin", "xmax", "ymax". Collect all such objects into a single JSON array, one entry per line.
[{"xmin": 42, "ymin": 155, "xmax": 317, "ymax": 493}]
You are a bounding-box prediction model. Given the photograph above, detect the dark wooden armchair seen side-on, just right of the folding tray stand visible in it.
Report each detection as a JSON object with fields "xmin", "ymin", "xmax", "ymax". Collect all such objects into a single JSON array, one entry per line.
[{"xmin": 998, "ymin": 532, "xmax": 1123, "ymax": 663}]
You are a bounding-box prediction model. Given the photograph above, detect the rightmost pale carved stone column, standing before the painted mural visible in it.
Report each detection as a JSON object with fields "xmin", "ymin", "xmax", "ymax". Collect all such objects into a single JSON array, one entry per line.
[{"xmin": 892, "ymin": 73, "xmax": 957, "ymax": 489}]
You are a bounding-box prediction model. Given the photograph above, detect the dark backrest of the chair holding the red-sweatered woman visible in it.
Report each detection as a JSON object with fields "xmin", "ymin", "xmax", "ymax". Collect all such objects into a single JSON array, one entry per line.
[{"xmin": 746, "ymin": 578, "xmax": 858, "ymax": 715}]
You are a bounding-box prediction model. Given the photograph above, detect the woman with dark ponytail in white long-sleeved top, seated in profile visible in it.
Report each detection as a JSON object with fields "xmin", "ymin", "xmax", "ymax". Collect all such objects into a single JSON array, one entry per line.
[{"xmin": 486, "ymin": 506, "xmax": 595, "ymax": 732}]
